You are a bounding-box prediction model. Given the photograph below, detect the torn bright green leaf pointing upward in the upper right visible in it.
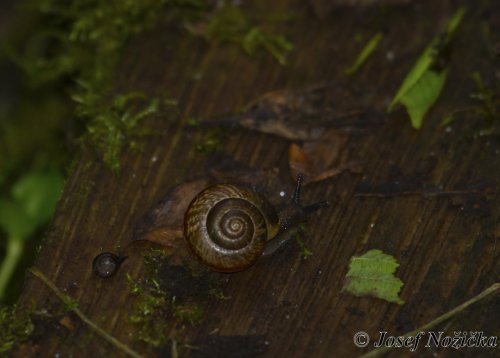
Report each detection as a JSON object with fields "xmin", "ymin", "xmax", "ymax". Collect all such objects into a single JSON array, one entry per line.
[{"xmin": 387, "ymin": 7, "xmax": 465, "ymax": 129}]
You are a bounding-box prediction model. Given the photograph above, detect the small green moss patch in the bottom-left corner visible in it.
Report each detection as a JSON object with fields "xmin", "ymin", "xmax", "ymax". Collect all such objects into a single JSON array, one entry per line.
[{"xmin": 0, "ymin": 306, "xmax": 33, "ymax": 354}]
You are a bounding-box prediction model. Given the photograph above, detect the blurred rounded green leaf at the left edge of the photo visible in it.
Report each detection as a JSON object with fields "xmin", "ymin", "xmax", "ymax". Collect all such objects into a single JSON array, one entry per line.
[{"xmin": 0, "ymin": 172, "xmax": 63, "ymax": 240}]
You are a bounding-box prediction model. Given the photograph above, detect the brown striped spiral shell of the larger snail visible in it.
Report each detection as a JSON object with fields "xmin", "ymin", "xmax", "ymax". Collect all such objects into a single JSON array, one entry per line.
[{"xmin": 184, "ymin": 184, "xmax": 280, "ymax": 272}]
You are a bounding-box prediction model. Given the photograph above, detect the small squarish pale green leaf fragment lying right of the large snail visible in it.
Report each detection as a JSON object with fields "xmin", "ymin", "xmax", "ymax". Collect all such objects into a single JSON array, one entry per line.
[{"xmin": 343, "ymin": 250, "xmax": 404, "ymax": 304}]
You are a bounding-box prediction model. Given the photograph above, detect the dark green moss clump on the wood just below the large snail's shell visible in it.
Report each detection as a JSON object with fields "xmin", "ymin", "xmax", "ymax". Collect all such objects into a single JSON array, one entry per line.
[{"xmin": 128, "ymin": 251, "xmax": 225, "ymax": 349}]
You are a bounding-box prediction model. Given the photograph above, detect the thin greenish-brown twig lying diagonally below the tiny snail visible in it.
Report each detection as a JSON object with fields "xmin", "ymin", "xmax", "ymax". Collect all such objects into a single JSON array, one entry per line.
[{"xmin": 28, "ymin": 267, "xmax": 142, "ymax": 358}]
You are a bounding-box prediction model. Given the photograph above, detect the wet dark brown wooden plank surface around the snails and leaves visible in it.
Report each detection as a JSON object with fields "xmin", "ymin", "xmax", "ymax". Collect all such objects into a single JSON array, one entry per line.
[{"xmin": 18, "ymin": 0, "xmax": 500, "ymax": 357}]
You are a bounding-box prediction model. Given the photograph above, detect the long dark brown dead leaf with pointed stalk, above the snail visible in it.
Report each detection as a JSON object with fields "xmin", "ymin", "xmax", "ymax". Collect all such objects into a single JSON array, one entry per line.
[{"xmin": 203, "ymin": 83, "xmax": 385, "ymax": 141}]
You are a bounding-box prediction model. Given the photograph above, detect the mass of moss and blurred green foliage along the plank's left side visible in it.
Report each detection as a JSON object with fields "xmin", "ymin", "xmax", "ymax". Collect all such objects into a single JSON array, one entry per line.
[{"xmin": 0, "ymin": 0, "xmax": 204, "ymax": 302}]
